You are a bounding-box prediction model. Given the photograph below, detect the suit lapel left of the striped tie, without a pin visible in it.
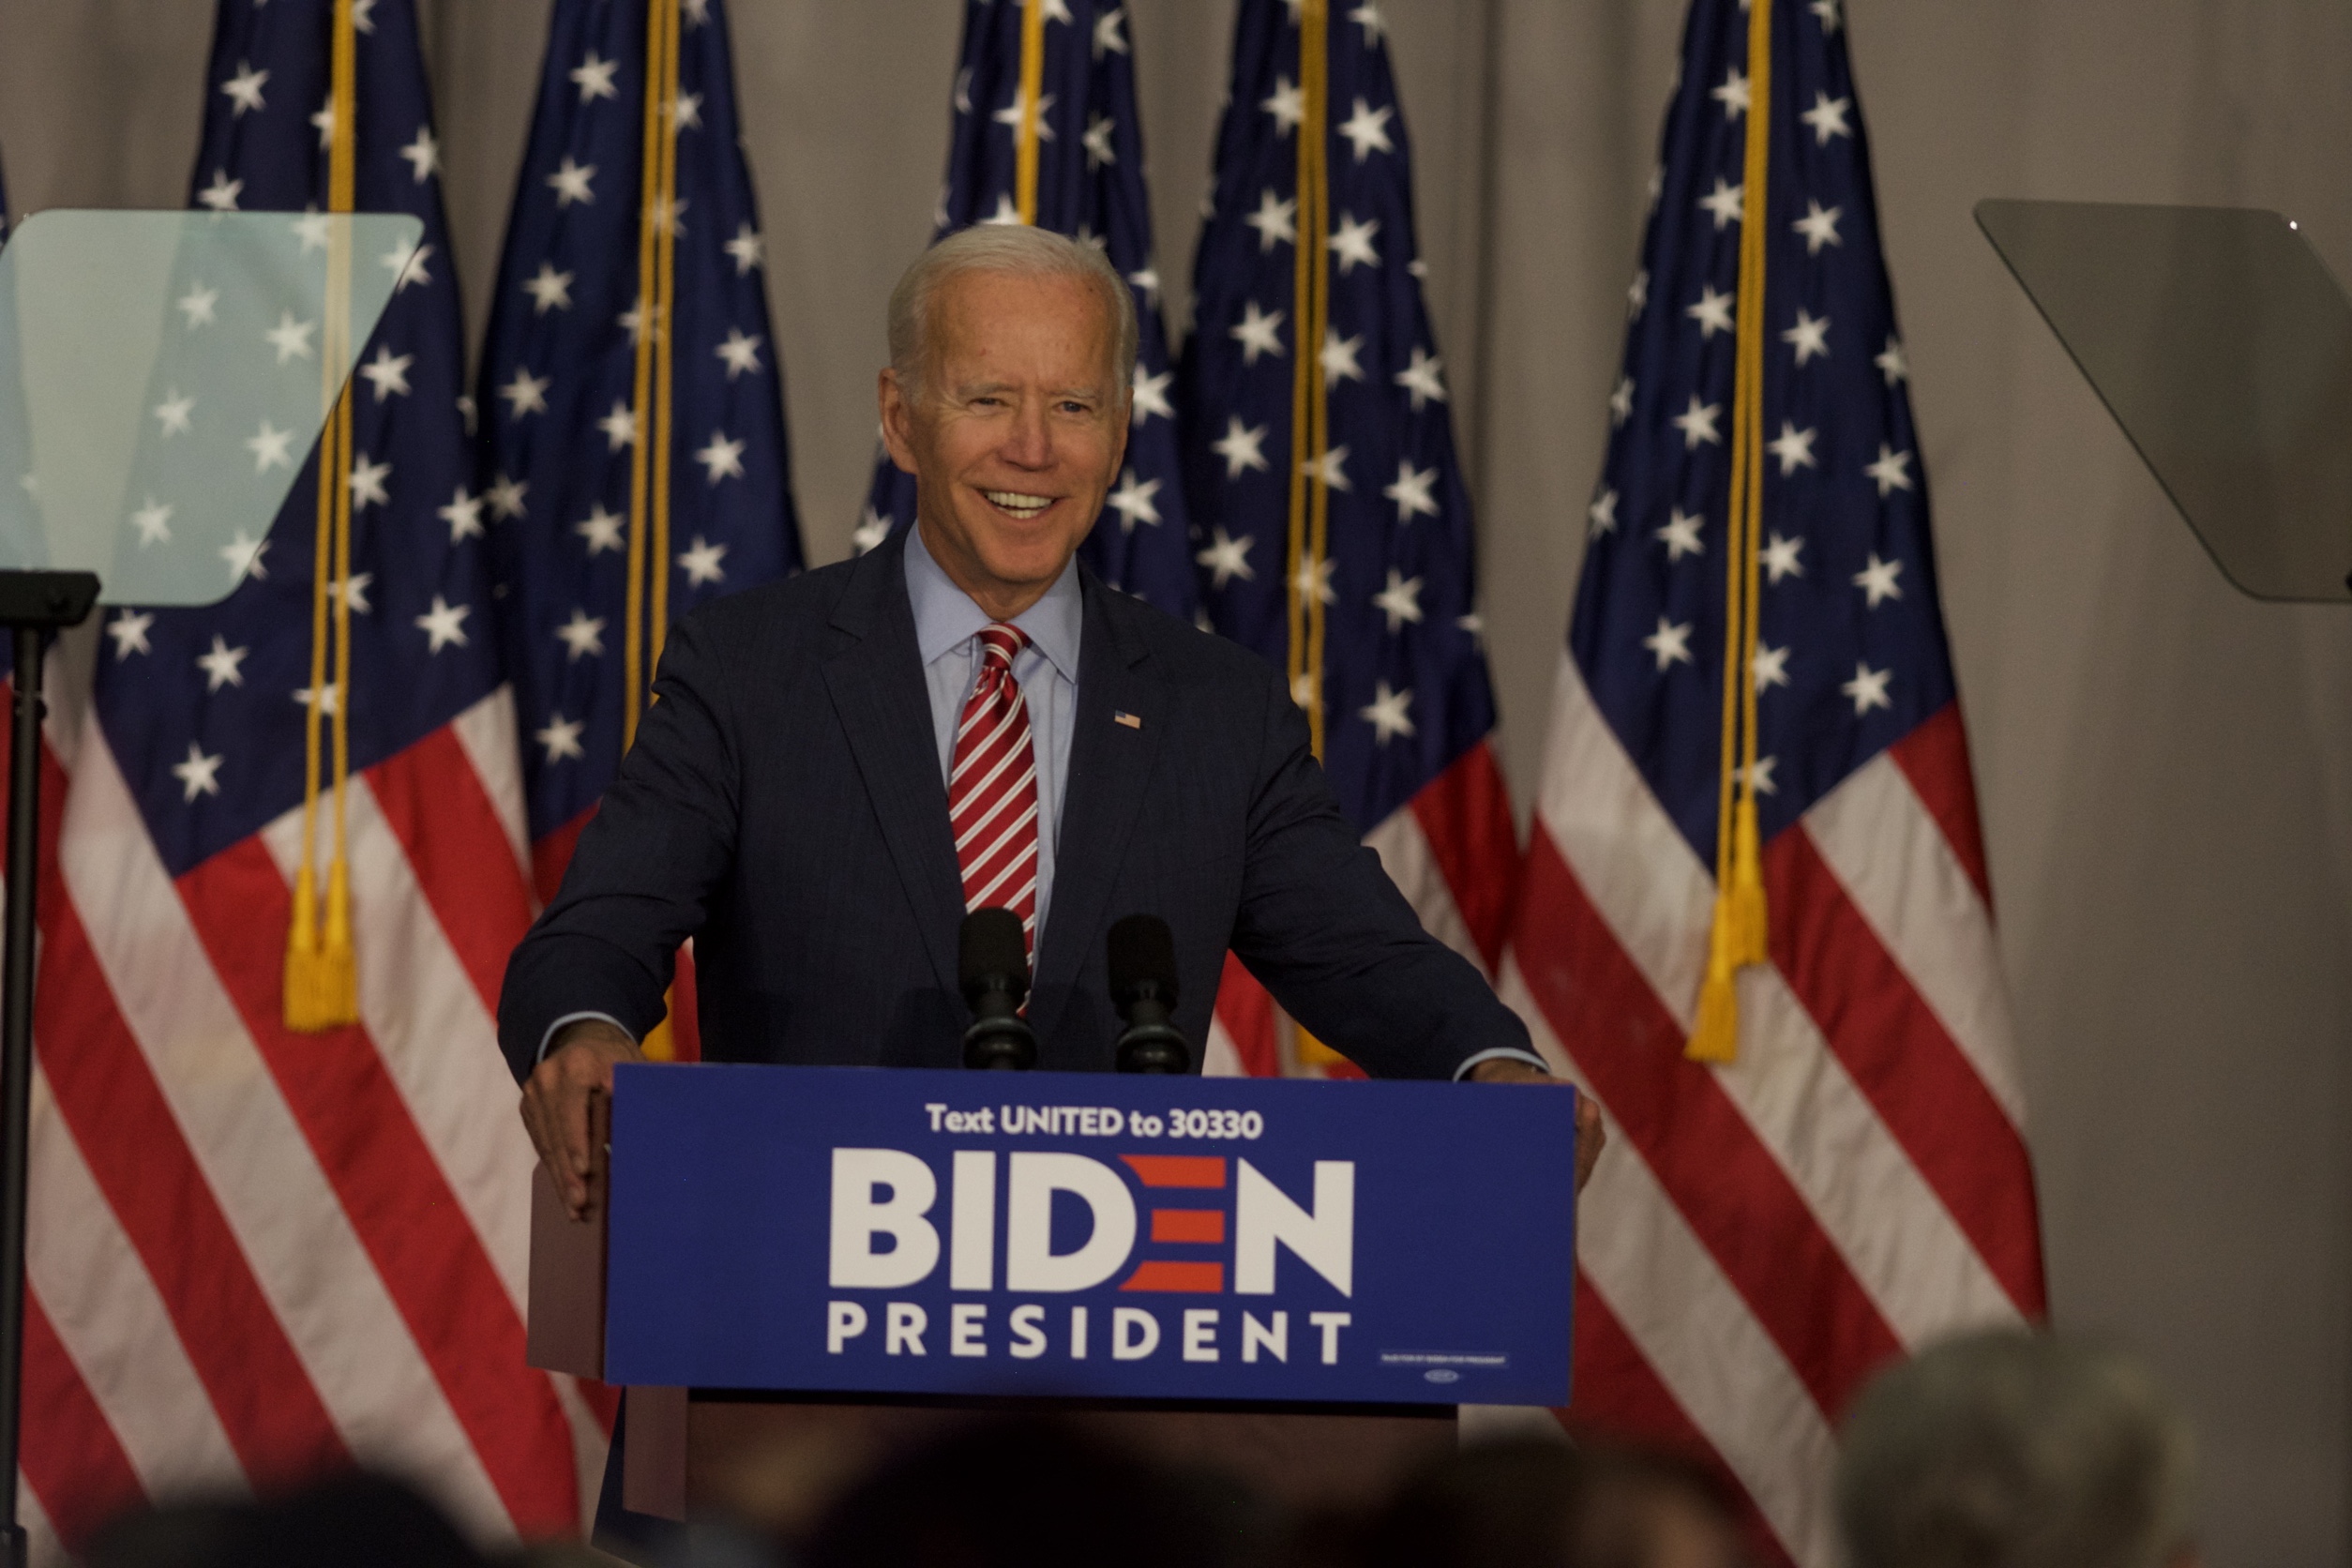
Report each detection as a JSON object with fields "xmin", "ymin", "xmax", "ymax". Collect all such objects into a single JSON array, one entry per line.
[{"xmin": 816, "ymin": 534, "xmax": 964, "ymax": 992}]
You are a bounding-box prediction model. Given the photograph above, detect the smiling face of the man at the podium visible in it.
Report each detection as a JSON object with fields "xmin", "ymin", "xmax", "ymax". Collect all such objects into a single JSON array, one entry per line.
[{"xmin": 882, "ymin": 273, "xmax": 1126, "ymax": 621}]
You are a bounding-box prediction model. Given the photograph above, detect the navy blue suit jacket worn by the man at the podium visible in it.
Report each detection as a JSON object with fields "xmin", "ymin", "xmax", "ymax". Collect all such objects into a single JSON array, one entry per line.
[{"xmin": 499, "ymin": 526, "xmax": 1527, "ymax": 1079}]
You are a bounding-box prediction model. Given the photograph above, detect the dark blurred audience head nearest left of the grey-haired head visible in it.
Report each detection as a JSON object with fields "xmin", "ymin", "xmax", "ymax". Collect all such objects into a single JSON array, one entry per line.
[{"xmin": 1362, "ymin": 1441, "xmax": 1742, "ymax": 1568}]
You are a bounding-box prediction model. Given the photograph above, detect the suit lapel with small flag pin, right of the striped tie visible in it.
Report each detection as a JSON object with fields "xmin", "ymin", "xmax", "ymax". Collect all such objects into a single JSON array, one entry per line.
[{"xmin": 1031, "ymin": 569, "xmax": 1168, "ymax": 1036}]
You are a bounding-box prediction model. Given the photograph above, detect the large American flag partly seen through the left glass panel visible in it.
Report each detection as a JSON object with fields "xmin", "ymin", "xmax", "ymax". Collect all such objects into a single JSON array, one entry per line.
[{"xmin": 23, "ymin": 0, "xmax": 602, "ymax": 1559}]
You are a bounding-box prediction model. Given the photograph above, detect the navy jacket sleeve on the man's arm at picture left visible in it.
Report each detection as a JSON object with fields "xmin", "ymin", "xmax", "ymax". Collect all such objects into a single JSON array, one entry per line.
[{"xmin": 499, "ymin": 618, "xmax": 741, "ymax": 1079}]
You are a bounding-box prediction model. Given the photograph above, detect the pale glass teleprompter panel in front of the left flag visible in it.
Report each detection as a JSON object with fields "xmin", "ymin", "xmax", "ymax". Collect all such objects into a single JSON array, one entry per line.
[{"xmin": 0, "ymin": 212, "xmax": 423, "ymax": 604}]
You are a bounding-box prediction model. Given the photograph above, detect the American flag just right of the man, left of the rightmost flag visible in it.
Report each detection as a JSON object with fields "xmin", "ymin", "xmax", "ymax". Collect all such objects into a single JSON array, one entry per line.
[{"xmin": 1179, "ymin": 0, "xmax": 1517, "ymax": 1075}]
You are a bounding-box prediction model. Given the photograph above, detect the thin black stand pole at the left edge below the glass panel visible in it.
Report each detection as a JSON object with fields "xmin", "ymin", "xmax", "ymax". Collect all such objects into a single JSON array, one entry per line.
[{"xmin": 0, "ymin": 626, "xmax": 40, "ymax": 1568}]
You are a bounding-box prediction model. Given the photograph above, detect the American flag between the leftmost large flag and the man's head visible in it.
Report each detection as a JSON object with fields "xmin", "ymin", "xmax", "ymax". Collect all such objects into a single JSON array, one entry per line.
[{"xmin": 480, "ymin": 0, "xmax": 802, "ymax": 940}]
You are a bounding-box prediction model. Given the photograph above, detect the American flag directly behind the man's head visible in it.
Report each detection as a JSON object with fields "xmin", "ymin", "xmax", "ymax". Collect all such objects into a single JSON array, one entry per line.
[{"xmin": 853, "ymin": 0, "xmax": 1199, "ymax": 618}]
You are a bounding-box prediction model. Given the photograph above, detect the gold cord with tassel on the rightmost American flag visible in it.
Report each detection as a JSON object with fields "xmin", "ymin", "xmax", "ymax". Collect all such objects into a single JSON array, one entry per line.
[{"xmin": 1684, "ymin": 0, "xmax": 1772, "ymax": 1065}]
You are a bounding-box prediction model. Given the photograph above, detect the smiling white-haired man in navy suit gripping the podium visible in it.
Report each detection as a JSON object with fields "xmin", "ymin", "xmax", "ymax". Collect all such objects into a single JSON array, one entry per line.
[{"xmin": 499, "ymin": 226, "xmax": 1599, "ymax": 1215}]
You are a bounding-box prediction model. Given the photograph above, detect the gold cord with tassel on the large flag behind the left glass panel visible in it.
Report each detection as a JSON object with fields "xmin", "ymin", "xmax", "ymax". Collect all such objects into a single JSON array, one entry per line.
[{"xmin": 282, "ymin": 0, "xmax": 360, "ymax": 1032}]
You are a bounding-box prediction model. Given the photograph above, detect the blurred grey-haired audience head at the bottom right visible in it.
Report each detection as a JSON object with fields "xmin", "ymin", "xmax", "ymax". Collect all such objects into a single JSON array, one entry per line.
[{"xmin": 1837, "ymin": 1331, "xmax": 2194, "ymax": 1568}]
